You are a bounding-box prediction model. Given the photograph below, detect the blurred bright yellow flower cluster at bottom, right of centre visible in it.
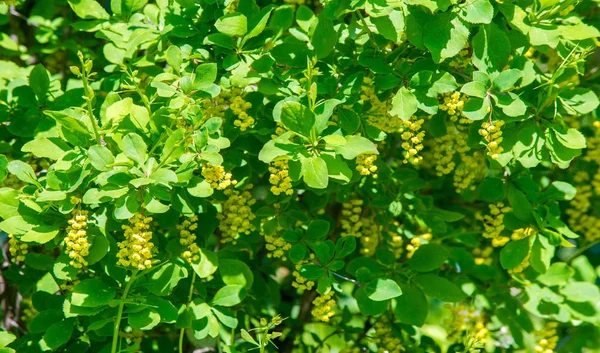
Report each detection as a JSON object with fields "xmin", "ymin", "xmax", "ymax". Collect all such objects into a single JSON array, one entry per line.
[{"xmin": 445, "ymin": 303, "xmax": 489, "ymax": 346}]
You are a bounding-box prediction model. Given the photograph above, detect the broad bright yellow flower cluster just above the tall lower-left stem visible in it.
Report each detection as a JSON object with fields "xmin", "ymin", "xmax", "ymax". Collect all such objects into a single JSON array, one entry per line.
[{"xmin": 117, "ymin": 212, "xmax": 154, "ymax": 270}]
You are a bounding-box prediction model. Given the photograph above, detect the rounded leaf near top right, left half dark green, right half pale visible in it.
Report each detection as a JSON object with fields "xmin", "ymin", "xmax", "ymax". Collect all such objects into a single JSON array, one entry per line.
[{"xmin": 423, "ymin": 12, "xmax": 469, "ymax": 63}]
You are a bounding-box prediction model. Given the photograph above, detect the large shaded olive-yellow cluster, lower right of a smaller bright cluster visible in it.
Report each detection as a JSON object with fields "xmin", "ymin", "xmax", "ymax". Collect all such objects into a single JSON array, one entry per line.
[{"xmin": 217, "ymin": 184, "xmax": 256, "ymax": 244}]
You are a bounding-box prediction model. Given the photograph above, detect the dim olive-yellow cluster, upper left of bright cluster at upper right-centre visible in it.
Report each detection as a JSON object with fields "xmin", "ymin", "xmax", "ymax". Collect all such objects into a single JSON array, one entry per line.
[{"xmin": 360, "ymin": 77, "xmax": 402, "ymax": 134}]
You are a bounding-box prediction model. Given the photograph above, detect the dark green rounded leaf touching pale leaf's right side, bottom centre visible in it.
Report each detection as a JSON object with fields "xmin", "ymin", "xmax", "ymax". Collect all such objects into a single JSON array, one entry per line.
[{"xmin": 394, "ymin": 284, "xmax": 429, "ymax": 327}]
